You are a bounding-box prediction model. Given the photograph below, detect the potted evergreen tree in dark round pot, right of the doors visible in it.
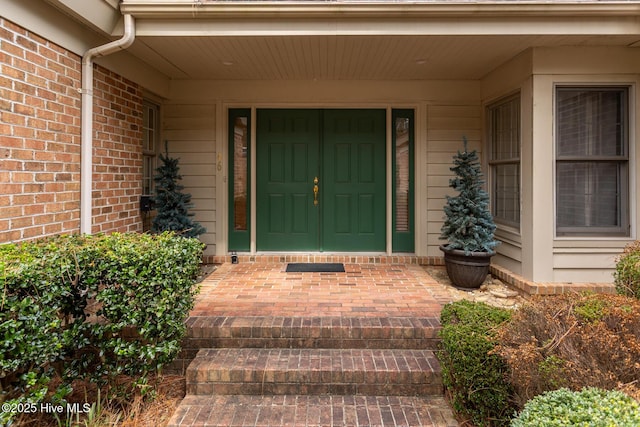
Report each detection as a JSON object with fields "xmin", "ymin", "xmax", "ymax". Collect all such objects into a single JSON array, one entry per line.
[{"xmin": 440, "ymin": 137, "xmax": 500, "ymax": 289}]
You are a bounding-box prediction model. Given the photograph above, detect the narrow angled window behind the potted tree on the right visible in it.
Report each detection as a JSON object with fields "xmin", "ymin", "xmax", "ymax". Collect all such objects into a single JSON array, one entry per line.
[{"xmin": 487, "ymin": 95, "xmax": 520, "ymax": 228}]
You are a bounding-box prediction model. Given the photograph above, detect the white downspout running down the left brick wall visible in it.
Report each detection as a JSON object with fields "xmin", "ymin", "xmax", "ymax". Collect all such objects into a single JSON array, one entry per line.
[{"xmin": 80, "ymin": 15, "xmax": 136, "ymax": 234}]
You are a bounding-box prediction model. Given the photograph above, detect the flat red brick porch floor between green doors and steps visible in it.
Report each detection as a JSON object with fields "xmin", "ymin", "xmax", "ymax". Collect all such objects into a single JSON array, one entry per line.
[{"xmin": 191, "ymin": 263, "xmax": 450, "ymax": 317}]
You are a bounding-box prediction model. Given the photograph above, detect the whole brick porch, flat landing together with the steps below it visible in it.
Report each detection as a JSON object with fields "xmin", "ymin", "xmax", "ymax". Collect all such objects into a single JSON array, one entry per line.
[{"xmin": 168, "ymin": 262, "xmax": 458, "ymax": 427}]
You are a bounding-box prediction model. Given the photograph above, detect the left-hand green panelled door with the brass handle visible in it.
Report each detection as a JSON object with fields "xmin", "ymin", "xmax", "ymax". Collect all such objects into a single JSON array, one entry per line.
[{"xmin": 256, "ymin": 110, "xmax": 320, "ymax": 251}]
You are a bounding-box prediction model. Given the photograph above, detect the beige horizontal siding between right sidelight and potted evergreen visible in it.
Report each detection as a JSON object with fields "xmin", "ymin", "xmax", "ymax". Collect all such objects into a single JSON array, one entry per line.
[{"xmin": 426, "ymin": 103, "xmax": 481, "ymax": 256}]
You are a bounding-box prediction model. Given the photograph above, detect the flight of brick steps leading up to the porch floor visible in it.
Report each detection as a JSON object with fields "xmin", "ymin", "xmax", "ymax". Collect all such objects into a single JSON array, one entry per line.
[{"xmin": 168, "ymin": 316, "xmax": 458, "ymax": 427}]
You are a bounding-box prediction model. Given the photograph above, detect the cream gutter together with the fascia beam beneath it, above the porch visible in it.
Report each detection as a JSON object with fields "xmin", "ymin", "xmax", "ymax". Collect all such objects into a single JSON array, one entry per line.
[{"xmin": 120, "ymin": 0, "xmax": 640, "ymax": 36}]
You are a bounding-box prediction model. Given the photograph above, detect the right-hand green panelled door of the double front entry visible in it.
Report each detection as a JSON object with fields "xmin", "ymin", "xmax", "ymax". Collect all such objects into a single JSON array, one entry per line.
[{"xmin": 321, "ymin": 110, "xmax": 386, "ymax": 251}]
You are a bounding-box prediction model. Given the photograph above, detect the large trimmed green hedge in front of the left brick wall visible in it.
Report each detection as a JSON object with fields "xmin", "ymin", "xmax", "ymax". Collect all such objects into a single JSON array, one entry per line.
[{"xmin": 0, "ymin": 233, "xmax": 204, "ymax": 424}]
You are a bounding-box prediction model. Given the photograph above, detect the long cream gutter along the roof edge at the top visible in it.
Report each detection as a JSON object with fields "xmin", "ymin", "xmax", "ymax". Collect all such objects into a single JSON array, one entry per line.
[{"xmin": 121, "ymin": 0, "xmax": 640, "ymax": 19}]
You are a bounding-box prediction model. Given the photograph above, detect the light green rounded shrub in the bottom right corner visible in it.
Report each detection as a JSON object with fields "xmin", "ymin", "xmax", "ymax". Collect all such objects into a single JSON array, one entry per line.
[{"xmin": 511, "ymin": 387, "xmax": 640, "ymax": 427}]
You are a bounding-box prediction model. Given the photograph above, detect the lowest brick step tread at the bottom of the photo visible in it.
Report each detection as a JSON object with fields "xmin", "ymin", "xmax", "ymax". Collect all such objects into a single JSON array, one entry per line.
[{"xmin": 168, "ymin": 395, "xmax": 458, "ymax": 427}]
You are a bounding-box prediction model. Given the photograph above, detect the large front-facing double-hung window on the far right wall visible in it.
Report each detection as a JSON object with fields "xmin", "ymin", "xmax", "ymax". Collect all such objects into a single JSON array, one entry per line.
[{"xmin": 556, "ymin": 87, "xmax": 629, "ymax": 236}]
